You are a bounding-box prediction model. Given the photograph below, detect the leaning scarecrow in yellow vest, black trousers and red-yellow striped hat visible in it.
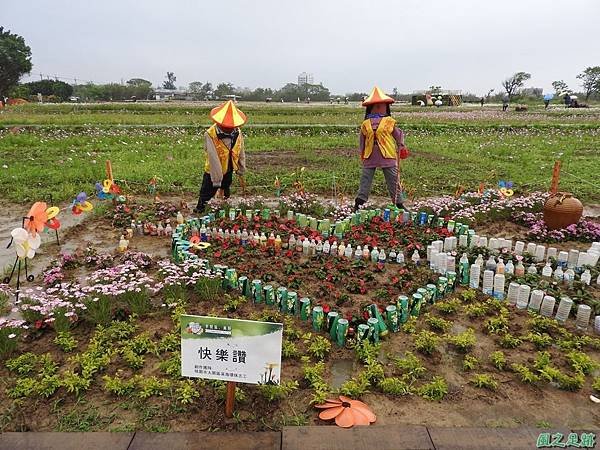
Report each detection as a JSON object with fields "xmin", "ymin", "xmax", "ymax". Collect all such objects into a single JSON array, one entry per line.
[{"xmin": 194, "ymin": 100, "xmax": 247, "ymax": 213}]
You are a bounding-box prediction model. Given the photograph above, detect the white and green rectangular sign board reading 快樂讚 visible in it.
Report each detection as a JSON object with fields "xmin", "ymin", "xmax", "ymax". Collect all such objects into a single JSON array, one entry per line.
[{"xmin": 181, "ymin": 315, "xmax": 283, "ymax": 384}]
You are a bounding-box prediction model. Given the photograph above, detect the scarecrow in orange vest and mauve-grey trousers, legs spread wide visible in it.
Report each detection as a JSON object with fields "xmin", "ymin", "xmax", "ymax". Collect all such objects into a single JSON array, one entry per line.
[{"xmin": 354, "ymin": 87, "xmax": 408, "ymax": 209}]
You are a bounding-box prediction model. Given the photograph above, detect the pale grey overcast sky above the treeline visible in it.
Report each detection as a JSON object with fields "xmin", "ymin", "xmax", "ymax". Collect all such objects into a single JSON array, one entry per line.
[{"xmin": 0, "ymin": 0, "xmax": 600, "ymax": 94}]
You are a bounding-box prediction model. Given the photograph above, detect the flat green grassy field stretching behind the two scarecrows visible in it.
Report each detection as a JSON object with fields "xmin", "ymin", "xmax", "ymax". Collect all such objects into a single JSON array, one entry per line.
[{"xmin": 0, "ymin": 103, "xmax": 600, "ymax": 203}]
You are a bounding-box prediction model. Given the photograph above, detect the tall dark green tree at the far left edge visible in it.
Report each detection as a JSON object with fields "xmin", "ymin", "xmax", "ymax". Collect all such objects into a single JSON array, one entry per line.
[{"xmin": 0, "ymin": 27, "xmax": 32, "ymax": 102}]
